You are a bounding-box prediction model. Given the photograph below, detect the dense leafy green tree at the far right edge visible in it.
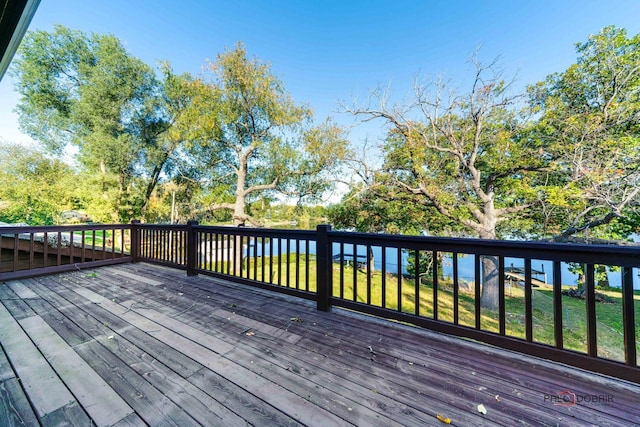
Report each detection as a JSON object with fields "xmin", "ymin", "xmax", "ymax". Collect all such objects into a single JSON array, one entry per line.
[{"xmin": 529, "ymin": 27, "xmax": 640, "ymax": 241}]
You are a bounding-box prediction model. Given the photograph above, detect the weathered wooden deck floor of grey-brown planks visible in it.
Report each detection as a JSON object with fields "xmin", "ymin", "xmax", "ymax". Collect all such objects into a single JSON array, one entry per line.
[{"xmin": 0, "ymin": 264, "xmax": 640, "ymax": 426}]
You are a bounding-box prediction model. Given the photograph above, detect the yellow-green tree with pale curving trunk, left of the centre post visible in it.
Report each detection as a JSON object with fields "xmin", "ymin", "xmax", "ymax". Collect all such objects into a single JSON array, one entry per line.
[{"xmin": 180, "ymin": 44, "xmax": 346, "ymax": 225}]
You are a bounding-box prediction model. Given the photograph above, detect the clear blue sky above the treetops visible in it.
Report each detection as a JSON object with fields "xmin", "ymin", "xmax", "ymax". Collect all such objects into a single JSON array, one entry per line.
[{"xmin": 0, "ymin": 0, "xmax": 640, "ymax": 147}]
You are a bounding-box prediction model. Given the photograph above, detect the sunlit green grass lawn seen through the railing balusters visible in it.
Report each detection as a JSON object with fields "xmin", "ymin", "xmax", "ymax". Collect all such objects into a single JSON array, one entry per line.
[{"xmin": 206, "ymin": 253, "xmax": 640, "ymax": 361}]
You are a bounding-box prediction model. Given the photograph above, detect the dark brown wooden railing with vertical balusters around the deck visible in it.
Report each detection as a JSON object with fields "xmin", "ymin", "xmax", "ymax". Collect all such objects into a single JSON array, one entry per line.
[{"xmin": 0, "ymin": 222, "xmax": 640, "ymax": 383}]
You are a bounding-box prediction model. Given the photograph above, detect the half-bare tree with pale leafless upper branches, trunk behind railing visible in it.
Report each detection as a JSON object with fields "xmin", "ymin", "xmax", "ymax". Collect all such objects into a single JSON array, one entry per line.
[{"xmin": 350, "ymin": 61, "xmax": 548, "ymax": 310}]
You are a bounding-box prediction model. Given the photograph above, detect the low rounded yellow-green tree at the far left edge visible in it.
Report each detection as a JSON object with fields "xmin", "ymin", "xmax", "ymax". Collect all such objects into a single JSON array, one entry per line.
[{"xmin": 0, "ymin": 144, "xmax": 82, "ymax": 225}]
